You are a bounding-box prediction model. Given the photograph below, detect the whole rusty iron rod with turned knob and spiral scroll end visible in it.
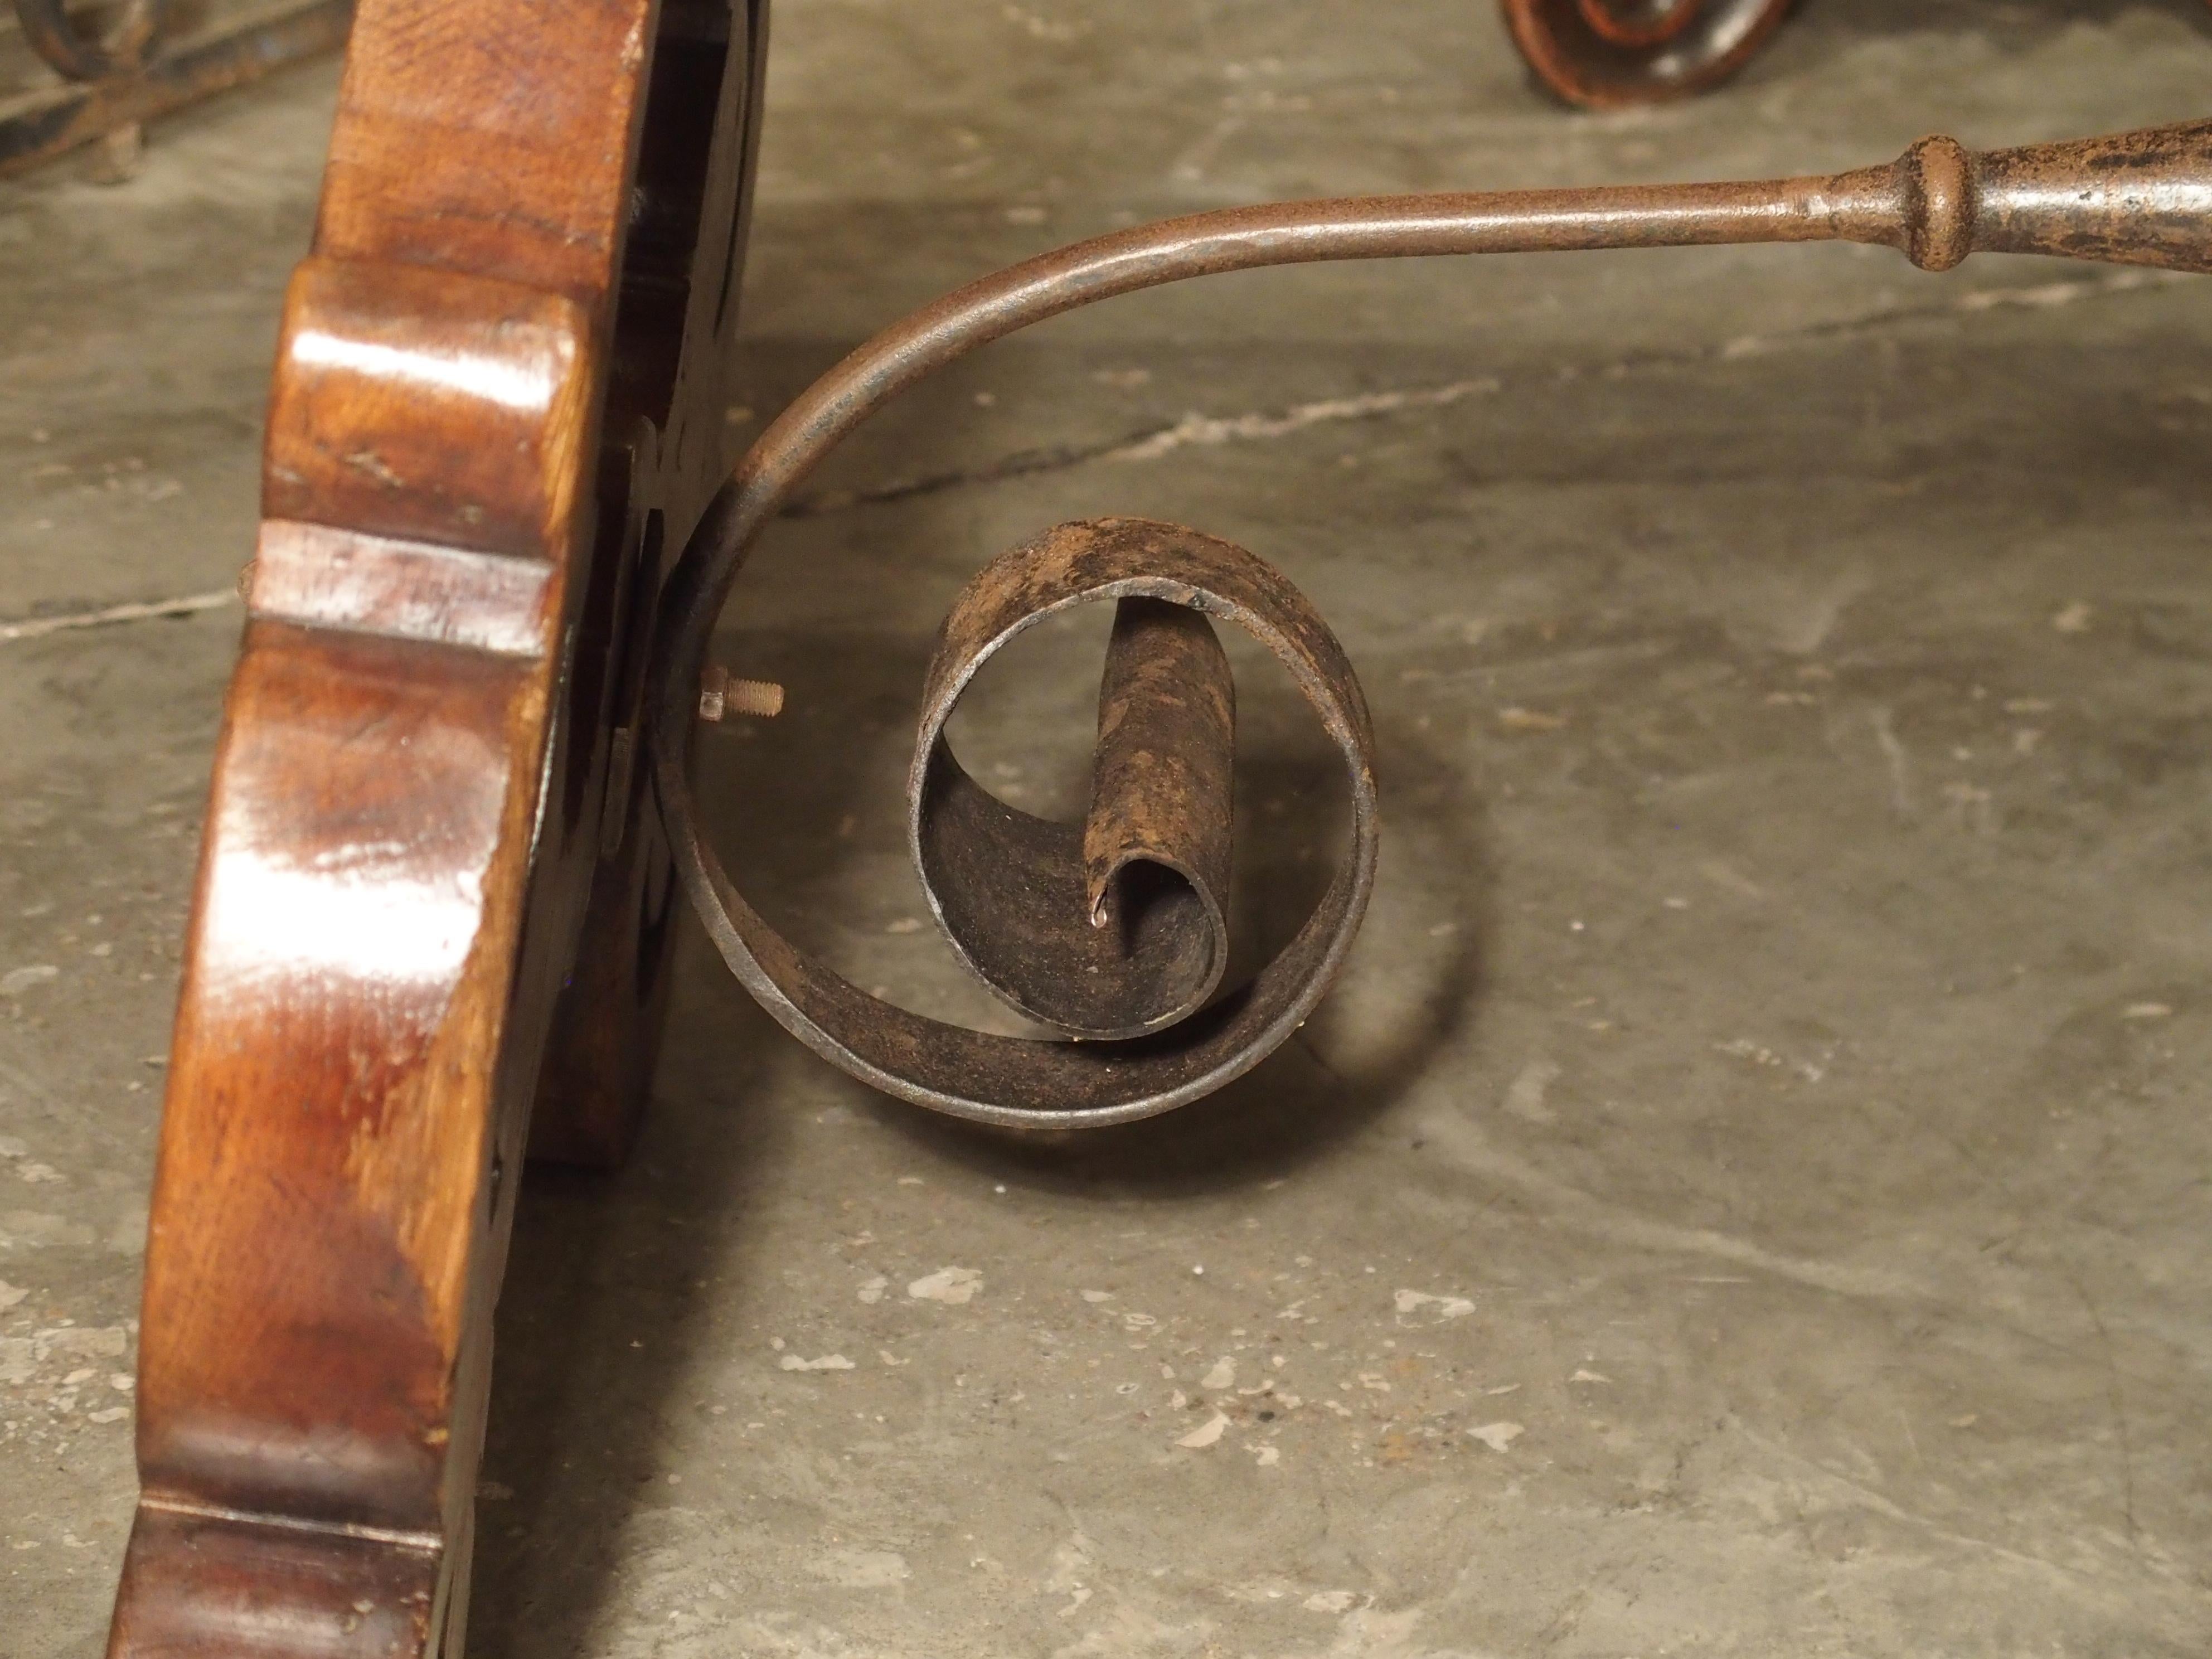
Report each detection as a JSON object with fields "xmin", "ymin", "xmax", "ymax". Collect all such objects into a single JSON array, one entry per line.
[{"xmin": 651, "ymin": 122, "xmax": 2212, "ymax": 1126}]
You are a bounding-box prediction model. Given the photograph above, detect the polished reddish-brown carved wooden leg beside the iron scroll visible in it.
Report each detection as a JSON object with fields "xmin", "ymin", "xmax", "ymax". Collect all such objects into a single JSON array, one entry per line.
[{"xmin": 110, "ymin": 0, "xmax": 763, "ymax": 1659}]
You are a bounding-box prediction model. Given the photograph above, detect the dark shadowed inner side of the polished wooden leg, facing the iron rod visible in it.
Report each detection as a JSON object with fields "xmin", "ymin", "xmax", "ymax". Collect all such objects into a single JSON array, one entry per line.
[{"xmin": 528, "ymin": 0, "xmax": 768, "ymax": 1166}]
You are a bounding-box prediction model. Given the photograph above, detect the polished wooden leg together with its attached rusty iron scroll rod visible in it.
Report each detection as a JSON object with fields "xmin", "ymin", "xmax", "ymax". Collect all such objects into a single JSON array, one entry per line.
[{"xmin": 110, "ymin": 0, "xmax": 2212, "ymax": 1659}]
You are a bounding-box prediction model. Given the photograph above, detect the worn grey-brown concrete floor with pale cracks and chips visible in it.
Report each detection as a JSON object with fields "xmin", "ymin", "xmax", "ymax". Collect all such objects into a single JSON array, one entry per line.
[{"xmin": 0, "ymin": 0, "xmax": 2212, "ymax": 1659}]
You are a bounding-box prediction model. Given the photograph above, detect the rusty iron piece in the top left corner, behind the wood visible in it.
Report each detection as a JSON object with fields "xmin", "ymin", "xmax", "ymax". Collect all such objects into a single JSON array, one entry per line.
[{"xmin": 0, "ymin": 0, "xmax": 354, "ymax": 179}]
